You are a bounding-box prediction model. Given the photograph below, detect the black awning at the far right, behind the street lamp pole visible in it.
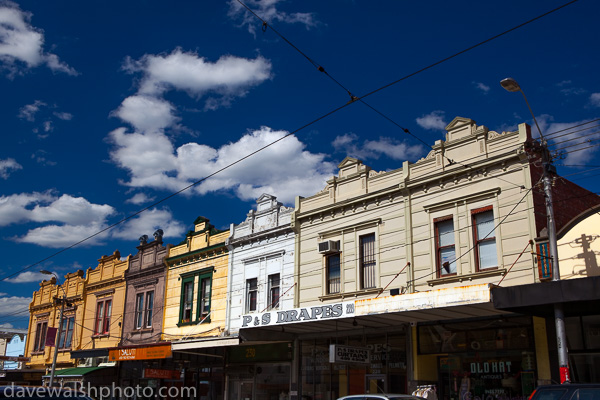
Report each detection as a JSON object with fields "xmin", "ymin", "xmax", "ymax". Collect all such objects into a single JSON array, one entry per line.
[{"xmin": 492, "ymin": 276, "xmax": 600, "ymax": 317}]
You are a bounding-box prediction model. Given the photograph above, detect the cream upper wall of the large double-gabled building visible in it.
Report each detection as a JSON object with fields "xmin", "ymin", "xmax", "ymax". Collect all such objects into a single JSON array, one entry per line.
[{"xmin": 292, "ymin": 117, "xmax": 537, "ymax": 306}]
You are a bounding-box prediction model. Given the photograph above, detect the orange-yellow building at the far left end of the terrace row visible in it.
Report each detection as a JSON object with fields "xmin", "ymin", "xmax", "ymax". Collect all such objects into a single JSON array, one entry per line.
[{"xmin": 25, "ymin": 270, "xmax": 85, "ymax": 370}]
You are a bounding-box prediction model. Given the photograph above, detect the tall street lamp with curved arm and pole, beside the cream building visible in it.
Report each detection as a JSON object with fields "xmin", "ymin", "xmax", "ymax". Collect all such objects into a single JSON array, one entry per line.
[{"xmin": 500, "ymin": 78, "xmax": 571, "ymax": 383}]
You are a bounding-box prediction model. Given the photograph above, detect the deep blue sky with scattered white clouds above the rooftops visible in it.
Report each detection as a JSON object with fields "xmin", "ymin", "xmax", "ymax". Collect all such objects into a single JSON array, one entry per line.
[{"xmin": 0, "ymin": 0, "xmax": 600, "ymax": 327}]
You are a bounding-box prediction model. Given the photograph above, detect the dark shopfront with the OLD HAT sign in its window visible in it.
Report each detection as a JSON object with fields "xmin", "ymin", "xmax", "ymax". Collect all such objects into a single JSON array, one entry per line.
[{"xmin": 417, "ymin": 316, "xmax": 537, "ymax": 400}]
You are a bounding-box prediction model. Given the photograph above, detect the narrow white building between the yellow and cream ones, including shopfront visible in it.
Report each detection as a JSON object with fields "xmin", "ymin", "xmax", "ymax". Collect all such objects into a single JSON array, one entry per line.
[{"xmin": 226, "ymin": 194, "xmax": 295, "ymax": 398}]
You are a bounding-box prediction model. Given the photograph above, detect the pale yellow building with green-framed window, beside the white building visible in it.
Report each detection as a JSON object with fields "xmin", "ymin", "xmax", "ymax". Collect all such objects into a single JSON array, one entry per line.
[{"xmin": 163, "ymin": 217, "xmax": 231, "ymax": 394}]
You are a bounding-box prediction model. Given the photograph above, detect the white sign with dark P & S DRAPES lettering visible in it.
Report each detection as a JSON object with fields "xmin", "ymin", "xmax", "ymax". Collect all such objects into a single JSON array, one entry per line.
[{"xmin": 242, "ymin": 301, "xmax": 354, "ymax": 328}]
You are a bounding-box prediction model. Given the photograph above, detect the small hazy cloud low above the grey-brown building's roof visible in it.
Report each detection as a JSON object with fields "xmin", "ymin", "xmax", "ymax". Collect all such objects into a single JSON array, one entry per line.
[{"xmin": 112, "ymin": 208, "xmax": 186, "ymax": 240}]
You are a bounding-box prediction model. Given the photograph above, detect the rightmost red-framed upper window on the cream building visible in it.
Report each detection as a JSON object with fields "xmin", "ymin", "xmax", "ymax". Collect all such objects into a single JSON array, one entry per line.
[{"xmin": 472, "ymin": 206, "xmax": 498, "ymax": 271}]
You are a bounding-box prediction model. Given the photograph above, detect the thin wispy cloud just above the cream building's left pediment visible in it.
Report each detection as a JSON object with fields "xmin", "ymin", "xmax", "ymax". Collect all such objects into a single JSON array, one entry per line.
[{"xmin": 332, "ymin": 133, "xmax": 423, "ymax": 160}]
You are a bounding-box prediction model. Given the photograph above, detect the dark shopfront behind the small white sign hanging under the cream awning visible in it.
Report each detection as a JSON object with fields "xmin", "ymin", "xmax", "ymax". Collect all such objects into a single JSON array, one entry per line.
[{"xmin": 300, "ymin": 328, "xmax": 407, "ymax": 400}]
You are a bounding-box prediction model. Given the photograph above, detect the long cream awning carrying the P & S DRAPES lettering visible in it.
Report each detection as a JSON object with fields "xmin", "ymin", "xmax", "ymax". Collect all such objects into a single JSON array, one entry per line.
[{"xmin": 240, "ymin": 284, "xmax": 507, "ymax": 342}]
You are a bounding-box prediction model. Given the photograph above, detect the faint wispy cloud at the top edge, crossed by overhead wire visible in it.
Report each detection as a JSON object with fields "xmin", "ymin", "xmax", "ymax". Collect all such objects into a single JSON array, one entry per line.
[{"xmin": 228, "ymin": 0, "xmax": 317, "ymax": 36}]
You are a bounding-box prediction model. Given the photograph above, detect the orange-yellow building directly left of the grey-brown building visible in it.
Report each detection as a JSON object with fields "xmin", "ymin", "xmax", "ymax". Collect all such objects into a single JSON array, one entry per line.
[{"xmin": 72, "ymin": 250, "xmax": 133, "ymax": 366}]
